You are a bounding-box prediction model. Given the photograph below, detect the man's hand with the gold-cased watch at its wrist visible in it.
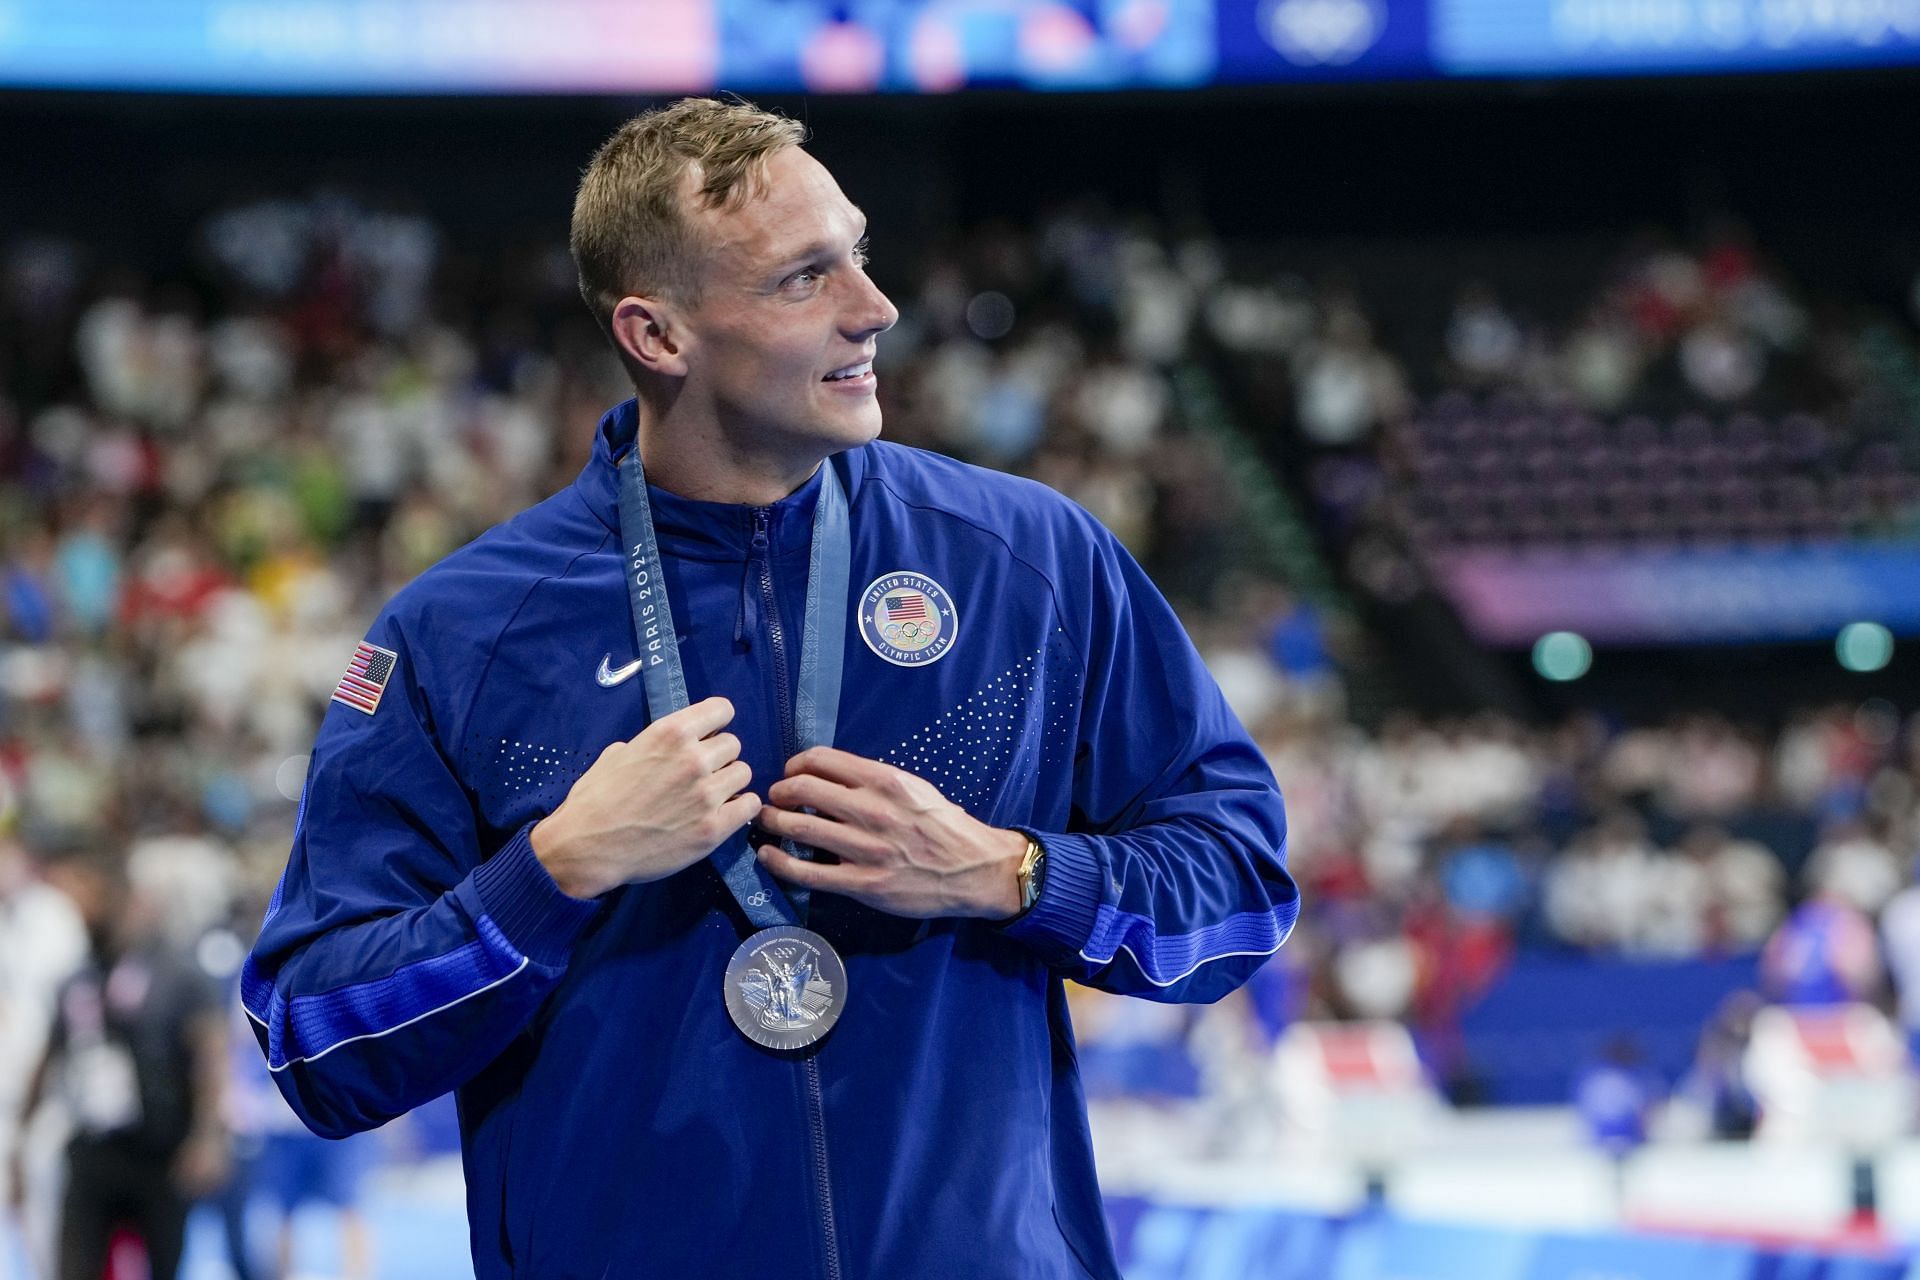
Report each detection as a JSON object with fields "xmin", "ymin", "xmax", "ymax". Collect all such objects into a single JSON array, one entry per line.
[{"xmin": 758, "ymin": 747, "xmax": 1027, "ymax": 919}]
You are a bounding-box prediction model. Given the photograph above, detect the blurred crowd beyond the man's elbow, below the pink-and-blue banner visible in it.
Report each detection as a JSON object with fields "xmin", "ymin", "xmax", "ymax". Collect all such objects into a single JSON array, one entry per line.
[{"xmin": 1261, "ymin": 700, "xmax": 1920, "ymax": 1032}]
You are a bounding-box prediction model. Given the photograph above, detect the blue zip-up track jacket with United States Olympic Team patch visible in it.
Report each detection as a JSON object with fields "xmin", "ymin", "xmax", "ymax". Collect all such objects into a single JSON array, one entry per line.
[{"xmin": 244, "ymin": 401, "xmax": 1298, "ymax": 1280}]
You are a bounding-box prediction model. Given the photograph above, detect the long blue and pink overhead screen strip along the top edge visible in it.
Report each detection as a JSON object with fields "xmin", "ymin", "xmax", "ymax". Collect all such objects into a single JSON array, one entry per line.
[{"xmin": 11, "ymin": 0, "xmax": 1920, "ymax": 94}]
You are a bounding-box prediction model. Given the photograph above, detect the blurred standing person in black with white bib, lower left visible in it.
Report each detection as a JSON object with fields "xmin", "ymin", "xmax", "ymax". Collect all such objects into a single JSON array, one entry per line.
[{"xmin": 10, "ymin": 846, "xmax": 228, "ymax": 1280}]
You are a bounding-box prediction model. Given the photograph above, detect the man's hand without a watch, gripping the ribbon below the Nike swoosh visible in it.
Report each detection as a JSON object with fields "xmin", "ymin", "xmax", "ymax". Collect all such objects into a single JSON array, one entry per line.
[{"xmin": 530, "ymin": 699, "xmax": 760, "ymax": 898}]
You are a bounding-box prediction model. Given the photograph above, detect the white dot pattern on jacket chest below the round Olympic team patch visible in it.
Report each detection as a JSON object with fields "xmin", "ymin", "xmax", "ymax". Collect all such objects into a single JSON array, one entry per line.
[{"xmin": 881, "ymin": 647, "xmax": 1079, "ymax": 806}]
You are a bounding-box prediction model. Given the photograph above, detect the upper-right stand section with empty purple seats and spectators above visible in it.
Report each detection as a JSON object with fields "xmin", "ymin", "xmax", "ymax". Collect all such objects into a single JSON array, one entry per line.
[{"xmin": 1204, "ymin": 221, "xmax": 1920, "ymax": 603}]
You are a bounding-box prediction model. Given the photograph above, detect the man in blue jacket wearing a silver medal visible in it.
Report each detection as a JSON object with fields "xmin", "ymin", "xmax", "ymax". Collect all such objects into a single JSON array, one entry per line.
[{"xmin": 246, "ymin": 100, "xmax": 1298, "ymax": 1280}]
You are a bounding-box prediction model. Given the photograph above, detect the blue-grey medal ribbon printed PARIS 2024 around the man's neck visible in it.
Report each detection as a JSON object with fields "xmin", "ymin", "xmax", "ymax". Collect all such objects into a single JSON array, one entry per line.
[{"xmin": 620, "ymin": 449, "xmax": 852, "ymax": 929}]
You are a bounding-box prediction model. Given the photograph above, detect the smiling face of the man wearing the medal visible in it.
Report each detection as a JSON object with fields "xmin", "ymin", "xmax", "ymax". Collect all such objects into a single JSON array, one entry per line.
[{"xmin": 680, "ymin": 148, "xmax": 900, "ymax": 461}]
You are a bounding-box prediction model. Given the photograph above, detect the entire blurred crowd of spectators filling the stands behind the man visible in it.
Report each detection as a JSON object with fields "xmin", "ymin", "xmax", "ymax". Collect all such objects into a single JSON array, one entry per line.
[{"xmin": 0, "ymin": 185, "xmax": 1920, "ymax": 1274}]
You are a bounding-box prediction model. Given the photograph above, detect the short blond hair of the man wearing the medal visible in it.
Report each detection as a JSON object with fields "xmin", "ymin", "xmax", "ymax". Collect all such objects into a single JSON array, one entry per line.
[{"xmin": 572, "ymin": 98, "xmax": 806, "ymax": 345}]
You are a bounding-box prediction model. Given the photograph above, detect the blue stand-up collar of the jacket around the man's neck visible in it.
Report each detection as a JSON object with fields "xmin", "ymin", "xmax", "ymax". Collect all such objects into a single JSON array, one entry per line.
[{"xmin": 574, "ymin": 399, "xmax": 860, "ymax": 560}]
